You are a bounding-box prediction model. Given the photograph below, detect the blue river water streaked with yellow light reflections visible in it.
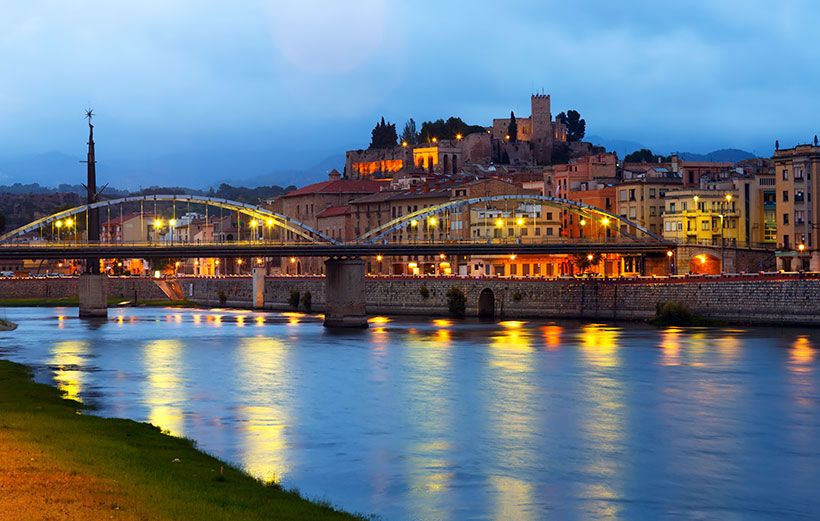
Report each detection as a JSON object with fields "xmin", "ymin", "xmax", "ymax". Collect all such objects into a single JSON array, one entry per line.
[{"xmin": 0, "ymin": 308, "xmax": 820, "ymax": 521}]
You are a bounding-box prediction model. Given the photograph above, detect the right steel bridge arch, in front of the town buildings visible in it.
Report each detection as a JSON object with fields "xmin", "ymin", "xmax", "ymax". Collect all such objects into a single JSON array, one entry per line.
[{"xmin": 356, "ymin": 194, "xmax": 664, "ymax": 244}]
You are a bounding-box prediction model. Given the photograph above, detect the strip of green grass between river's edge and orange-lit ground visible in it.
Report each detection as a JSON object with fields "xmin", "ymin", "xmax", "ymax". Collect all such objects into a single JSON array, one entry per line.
[{"xmin": 0, "ymin": 360, "xmax": 365, "ymax": 521}]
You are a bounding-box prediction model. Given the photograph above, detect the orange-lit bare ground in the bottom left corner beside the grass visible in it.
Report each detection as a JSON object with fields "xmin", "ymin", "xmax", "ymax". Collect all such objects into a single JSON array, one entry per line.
[{"xmin": 0, "ymin": 429, "xmax": 146, "ymax": 521}]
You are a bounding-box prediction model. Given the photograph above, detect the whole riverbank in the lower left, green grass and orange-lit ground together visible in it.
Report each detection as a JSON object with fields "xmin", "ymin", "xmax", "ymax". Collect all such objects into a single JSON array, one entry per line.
[{"xmin": 0, "ymin": 360, "xmax": 361, "ymax": 520}]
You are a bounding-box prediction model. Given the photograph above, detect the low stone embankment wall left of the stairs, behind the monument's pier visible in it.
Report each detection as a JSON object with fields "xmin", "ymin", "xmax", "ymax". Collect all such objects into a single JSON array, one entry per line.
[{"xmin": 0, "ymin": 277, "xmax": 167, "ymax": 301}]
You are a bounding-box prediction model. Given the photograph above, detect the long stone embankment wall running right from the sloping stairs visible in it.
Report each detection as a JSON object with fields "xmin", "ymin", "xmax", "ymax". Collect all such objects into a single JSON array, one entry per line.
[{"xmin": 180, "ymin": 276, "xmax": 820, "ymax": 325}]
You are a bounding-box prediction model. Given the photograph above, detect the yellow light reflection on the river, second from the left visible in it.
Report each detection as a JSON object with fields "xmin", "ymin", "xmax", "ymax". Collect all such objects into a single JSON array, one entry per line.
[{"xmin": 143, "ymin": 339, "xmax": 187, "ymax": 436}]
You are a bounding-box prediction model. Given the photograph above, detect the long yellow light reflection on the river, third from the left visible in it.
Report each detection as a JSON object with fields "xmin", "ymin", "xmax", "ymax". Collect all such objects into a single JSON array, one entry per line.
[{"xmin": 235, "ymin": 336, "xmax": 291, "ymax": 482}]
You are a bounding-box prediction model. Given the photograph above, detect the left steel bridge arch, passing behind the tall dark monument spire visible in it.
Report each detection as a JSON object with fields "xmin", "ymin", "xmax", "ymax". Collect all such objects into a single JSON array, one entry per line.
[{"xmin": 0, "ymin": 194, "xmax": 338, "ymax": 244}]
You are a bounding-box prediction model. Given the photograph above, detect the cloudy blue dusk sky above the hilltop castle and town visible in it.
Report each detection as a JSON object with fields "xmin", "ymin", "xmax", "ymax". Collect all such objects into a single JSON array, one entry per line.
[{"xmin": 0, "ymin": 0, "xmax": 820, "ymax": 187}]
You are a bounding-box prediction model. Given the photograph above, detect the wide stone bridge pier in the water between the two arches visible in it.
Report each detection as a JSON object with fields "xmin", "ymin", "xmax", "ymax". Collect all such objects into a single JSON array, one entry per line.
[{"xmin": 324, "ymin": 258, "xmax": 368, "ymax": 328}]
